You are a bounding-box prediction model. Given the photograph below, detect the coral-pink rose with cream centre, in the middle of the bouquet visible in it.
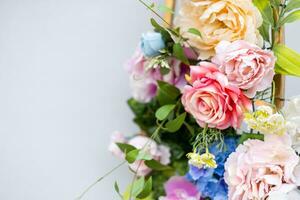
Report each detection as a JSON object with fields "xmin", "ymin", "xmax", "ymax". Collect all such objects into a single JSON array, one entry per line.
[{"xmin": 182, "ymin": 62, "xmax": 251, "ymax": 129}]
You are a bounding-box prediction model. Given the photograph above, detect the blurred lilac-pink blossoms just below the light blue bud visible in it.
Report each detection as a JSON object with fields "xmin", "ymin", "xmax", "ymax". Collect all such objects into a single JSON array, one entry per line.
[{"xmin": 125, "ymin": 48, "xmax": 188, "ymax": 103}]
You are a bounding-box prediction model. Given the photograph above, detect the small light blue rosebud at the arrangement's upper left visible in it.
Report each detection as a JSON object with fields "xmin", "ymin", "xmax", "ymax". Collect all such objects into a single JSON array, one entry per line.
[{"xmin": 141, "ymin": 32, "xmax": 165, "ymax": 57}]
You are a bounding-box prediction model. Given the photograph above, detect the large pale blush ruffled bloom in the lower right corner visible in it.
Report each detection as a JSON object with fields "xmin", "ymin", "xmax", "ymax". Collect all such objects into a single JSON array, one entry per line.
[{"xmin": 224, "ymin": 135, "xmax": 299, "ymax": 200}]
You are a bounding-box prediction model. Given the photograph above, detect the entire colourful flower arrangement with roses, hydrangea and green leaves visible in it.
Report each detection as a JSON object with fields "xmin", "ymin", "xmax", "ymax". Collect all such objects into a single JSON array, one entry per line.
[{"xmin": 75, "ymin": 0, "xmax": 300, "ymax": 200}]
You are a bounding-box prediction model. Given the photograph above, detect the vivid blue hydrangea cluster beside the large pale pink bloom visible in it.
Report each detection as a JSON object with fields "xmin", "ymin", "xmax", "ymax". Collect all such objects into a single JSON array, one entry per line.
[{"xmin": 187, "ymin": 137, "xmax": 237, "ymax": 200}]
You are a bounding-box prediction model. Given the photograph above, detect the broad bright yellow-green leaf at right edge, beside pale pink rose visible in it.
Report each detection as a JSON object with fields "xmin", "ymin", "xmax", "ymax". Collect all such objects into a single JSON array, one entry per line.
[{"xmin": 273, "ymin": 44, "xmax": 300, "ymax": 76}]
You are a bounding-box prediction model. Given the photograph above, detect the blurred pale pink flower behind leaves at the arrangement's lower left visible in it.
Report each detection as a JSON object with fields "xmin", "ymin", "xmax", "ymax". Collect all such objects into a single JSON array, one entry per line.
[{"xmin": 109, "ymin": 132, "xmax": 171, "ymax": 176}]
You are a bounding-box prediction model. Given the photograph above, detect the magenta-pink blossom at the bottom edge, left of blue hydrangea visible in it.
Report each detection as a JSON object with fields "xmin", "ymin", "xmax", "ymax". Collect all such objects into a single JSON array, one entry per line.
[{"xmin": 159, "ymin": 176, "xmax": 200, "ymax": 200}]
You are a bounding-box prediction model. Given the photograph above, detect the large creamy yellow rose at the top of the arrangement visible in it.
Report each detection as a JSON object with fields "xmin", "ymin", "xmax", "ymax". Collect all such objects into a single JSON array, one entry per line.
[{"xmin": 175, "ymin": 0, "xmax": 263, "ymax": 59}]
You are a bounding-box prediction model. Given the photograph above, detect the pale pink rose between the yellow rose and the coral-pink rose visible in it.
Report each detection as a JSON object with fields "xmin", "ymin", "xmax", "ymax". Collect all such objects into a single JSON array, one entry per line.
[{"xmin": 212, "ymin": 40, "xmax": 276, "ymax": 98}]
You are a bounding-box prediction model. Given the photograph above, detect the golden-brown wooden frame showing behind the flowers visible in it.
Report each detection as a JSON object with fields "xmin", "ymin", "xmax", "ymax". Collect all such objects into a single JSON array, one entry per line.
[{"xmin": 164, "ymin": 0, "xmax": 285, "ymax": 109}]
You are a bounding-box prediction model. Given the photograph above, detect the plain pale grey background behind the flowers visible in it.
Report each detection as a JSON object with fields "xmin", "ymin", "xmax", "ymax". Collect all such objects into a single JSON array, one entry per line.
[{"xmin": 0, "ymin": 0, "xmax": 300, "ymax": 200}]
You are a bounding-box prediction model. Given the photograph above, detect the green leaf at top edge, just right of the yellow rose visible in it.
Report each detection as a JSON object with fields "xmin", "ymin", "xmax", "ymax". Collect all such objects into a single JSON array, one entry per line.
[{"xmin": 253, "ymin": 0, "xmax": 274, "ymax": 26}]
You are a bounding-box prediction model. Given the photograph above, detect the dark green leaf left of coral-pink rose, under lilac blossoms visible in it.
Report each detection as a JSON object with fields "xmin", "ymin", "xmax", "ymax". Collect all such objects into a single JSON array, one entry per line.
[{"xmin": 157, "ymin": 81, "xmax": 180, "ymax": 105}]
